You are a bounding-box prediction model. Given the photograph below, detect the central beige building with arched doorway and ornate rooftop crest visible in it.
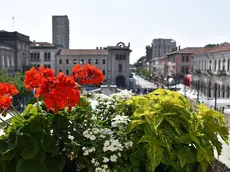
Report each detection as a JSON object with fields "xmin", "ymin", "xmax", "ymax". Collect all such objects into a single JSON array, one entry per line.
[{"xmin": 56, "ymin": 42, "xmax": 131, "ymax": 88}]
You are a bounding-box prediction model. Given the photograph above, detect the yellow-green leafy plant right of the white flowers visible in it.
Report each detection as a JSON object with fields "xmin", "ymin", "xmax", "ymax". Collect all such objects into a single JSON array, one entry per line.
[{"xmin": 126, "ymin": 89, "xmax": 228, "ymax": 172}]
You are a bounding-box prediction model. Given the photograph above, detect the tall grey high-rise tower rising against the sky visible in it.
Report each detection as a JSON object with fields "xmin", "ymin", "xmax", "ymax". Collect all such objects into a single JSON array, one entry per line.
[{"xmin": 52, "ymin": 15, "xmax": 69, "ymax": 49}]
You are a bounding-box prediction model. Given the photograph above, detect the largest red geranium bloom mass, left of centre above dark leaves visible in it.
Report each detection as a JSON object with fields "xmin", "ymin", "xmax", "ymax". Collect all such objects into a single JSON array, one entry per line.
[{"xmin": 24, "ymin": 67, "xmax": 80, "ymax": 113}]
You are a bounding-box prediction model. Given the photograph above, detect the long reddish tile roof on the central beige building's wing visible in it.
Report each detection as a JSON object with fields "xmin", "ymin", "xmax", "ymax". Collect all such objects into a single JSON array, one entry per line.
[{"xmin": 60, "ymin": 49, "xmax": 108, "ymax": 55}]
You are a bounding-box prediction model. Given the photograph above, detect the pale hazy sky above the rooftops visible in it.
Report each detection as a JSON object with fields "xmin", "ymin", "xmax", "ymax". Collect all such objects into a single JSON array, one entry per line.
[{"xmin": 0, "ymin": 0, "xmax": 230, "ymax": 63}]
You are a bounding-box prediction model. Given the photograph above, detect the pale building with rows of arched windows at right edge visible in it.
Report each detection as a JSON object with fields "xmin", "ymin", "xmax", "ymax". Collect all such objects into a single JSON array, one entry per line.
[{"xmin": 192, "ymin": 44, "xmax": 230, "ymax": 99}]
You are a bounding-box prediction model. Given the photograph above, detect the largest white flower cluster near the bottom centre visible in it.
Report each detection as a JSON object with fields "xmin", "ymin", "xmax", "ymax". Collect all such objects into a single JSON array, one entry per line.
[{"xmin": 103, "ymin": 139, "xmax": 123, "ymax": 152}]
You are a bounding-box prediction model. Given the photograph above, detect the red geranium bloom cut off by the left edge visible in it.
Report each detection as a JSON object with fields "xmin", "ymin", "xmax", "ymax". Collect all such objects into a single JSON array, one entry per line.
[{"xmin": 0, "ymin": 83, "xmax": 18, "ymax": 116}]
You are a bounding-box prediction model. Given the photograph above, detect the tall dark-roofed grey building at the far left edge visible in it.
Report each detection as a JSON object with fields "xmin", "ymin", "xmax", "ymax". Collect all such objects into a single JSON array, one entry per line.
[{"xmin": 0, "ymin": 31, "xmax": 30, "ymax": 72}]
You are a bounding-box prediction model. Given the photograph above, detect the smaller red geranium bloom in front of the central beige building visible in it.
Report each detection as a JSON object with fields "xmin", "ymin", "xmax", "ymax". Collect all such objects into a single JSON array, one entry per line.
[{"xmin": 72, "ymin": 63, "xmax": 104, "ymax": 85}]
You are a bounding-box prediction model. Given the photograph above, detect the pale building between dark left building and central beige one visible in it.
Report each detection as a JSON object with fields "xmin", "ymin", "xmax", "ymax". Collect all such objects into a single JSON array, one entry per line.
[{"xmin": 30, "ymin": 42, "xmax": 59, "ymax": 74}]
